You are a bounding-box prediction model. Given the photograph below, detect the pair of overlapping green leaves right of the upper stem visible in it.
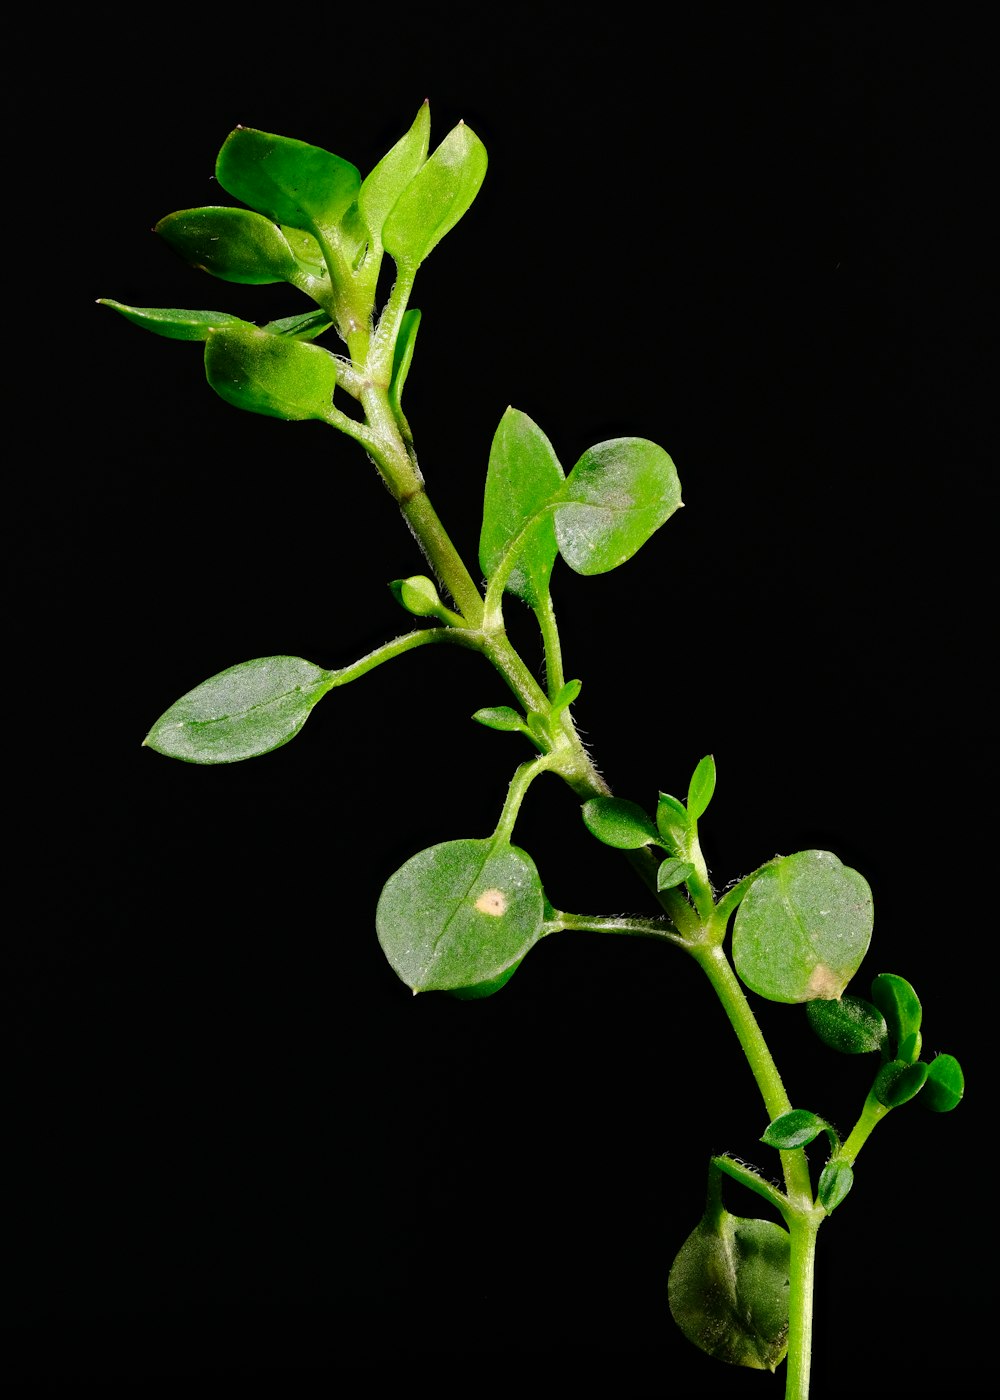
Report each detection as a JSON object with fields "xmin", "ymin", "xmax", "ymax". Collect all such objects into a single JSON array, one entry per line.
[{"xmin": 479, "ymin": 409, "xmax": 681, "ymax": 608}]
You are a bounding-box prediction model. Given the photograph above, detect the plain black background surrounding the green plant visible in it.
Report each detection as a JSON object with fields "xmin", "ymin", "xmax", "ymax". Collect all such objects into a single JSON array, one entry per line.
[{"xmin": 6, "ymin": 4, "xmax": 994, "ymax": 1400}]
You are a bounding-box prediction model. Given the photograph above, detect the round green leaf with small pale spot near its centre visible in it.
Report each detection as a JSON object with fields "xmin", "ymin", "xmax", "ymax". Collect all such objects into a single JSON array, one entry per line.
[{"xmin": 375, "ymin": 840, "xmax": 545, "ymax": 991}]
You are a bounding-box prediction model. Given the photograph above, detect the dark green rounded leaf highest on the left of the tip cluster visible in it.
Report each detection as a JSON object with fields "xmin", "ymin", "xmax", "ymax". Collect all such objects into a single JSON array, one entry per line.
[{"xmin": 216, "ymin": 126, "xmax": 361, "ymax": 238}]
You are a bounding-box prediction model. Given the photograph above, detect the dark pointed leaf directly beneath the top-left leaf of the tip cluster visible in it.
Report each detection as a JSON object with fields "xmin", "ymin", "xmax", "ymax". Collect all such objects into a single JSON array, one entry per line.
[{"xmin": 154, "ymin": 207, "xmax": 298, "ymax": 286}]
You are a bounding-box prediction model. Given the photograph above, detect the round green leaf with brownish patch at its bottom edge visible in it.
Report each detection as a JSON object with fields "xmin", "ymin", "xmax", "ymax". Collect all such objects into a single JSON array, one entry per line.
[{"xmin": 732, "ymin": 851, "xmax": 873, "ymax": 1002}]
